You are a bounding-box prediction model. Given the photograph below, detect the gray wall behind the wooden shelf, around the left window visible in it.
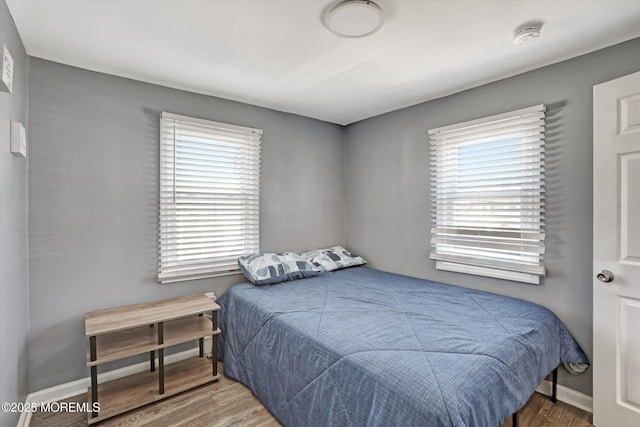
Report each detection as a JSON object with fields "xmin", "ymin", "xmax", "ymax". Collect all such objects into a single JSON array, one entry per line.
[{"xmin": 29, "ymin": 58, "xmax": 344, "ymax": 391}]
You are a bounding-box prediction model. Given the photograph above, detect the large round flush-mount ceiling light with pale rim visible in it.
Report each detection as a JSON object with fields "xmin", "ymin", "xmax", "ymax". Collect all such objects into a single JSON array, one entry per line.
[{"xmin": 325, "ymin": 0, "xmax": 384, "ymax": 38}]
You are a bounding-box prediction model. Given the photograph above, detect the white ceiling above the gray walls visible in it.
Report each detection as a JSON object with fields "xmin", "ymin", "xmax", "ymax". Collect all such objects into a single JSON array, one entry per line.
[{"xmin": 7, "ymin": 0, "xmax": 640, "ymax": 125}]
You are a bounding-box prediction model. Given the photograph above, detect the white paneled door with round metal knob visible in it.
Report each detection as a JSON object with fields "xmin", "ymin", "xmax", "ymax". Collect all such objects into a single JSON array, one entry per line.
[{"xmin": 593, "ymin": 72, "xmax": 640, "ymax": 427}]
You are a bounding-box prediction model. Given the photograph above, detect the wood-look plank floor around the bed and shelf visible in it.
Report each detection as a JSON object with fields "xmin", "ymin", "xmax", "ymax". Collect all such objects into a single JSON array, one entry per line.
[{"xmin": 30, "ymin": 365, "xmax": 592, "ymax": 427}]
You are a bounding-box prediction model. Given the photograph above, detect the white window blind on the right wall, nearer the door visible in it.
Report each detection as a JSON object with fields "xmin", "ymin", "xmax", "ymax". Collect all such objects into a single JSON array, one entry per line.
[{"xmin": 429, "ymin": 105, "xmax": 545, "ymax": 283}]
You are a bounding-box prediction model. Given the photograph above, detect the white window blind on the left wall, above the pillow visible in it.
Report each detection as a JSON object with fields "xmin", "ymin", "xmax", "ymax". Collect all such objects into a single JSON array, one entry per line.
[{"xmin": 158, "ymin": 112, "xmax": 262, "ymax": 283}]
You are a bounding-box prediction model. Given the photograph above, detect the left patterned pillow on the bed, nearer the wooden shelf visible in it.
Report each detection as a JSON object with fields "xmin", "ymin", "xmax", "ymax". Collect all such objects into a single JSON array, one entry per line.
[{"xmin": 238, "ymin": 252, "xmax": 320, "ymax": 285}]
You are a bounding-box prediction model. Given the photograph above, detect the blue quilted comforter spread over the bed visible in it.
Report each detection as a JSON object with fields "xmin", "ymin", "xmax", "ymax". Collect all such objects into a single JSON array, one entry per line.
[{"xmin": 219, "ymin": 267, "xmax": 588, "ymax": 427}]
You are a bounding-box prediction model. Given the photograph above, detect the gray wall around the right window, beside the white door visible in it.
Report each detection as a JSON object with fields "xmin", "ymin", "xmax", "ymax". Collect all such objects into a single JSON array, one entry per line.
[{"xmin": 345, "ymin": 39, "xmax": 640, "ymax": 394}]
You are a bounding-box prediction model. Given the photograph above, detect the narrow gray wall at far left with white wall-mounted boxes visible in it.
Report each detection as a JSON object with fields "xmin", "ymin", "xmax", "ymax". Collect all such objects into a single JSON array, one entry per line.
[{"xmin": 0, "ymin": 0, "xmax": 29, "ymax": 426}]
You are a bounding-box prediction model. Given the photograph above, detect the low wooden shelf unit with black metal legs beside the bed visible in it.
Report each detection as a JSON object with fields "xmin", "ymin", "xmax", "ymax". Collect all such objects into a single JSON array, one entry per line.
[{"xmin": 85, "ymin": 294, "xmax": 220, "ymax": 424}]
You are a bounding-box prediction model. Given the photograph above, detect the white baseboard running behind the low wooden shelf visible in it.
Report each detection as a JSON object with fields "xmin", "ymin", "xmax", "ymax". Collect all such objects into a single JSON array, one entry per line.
[{"xmin": 17, "ymin": 348, "xmax": 198, "ymax": 427}]
